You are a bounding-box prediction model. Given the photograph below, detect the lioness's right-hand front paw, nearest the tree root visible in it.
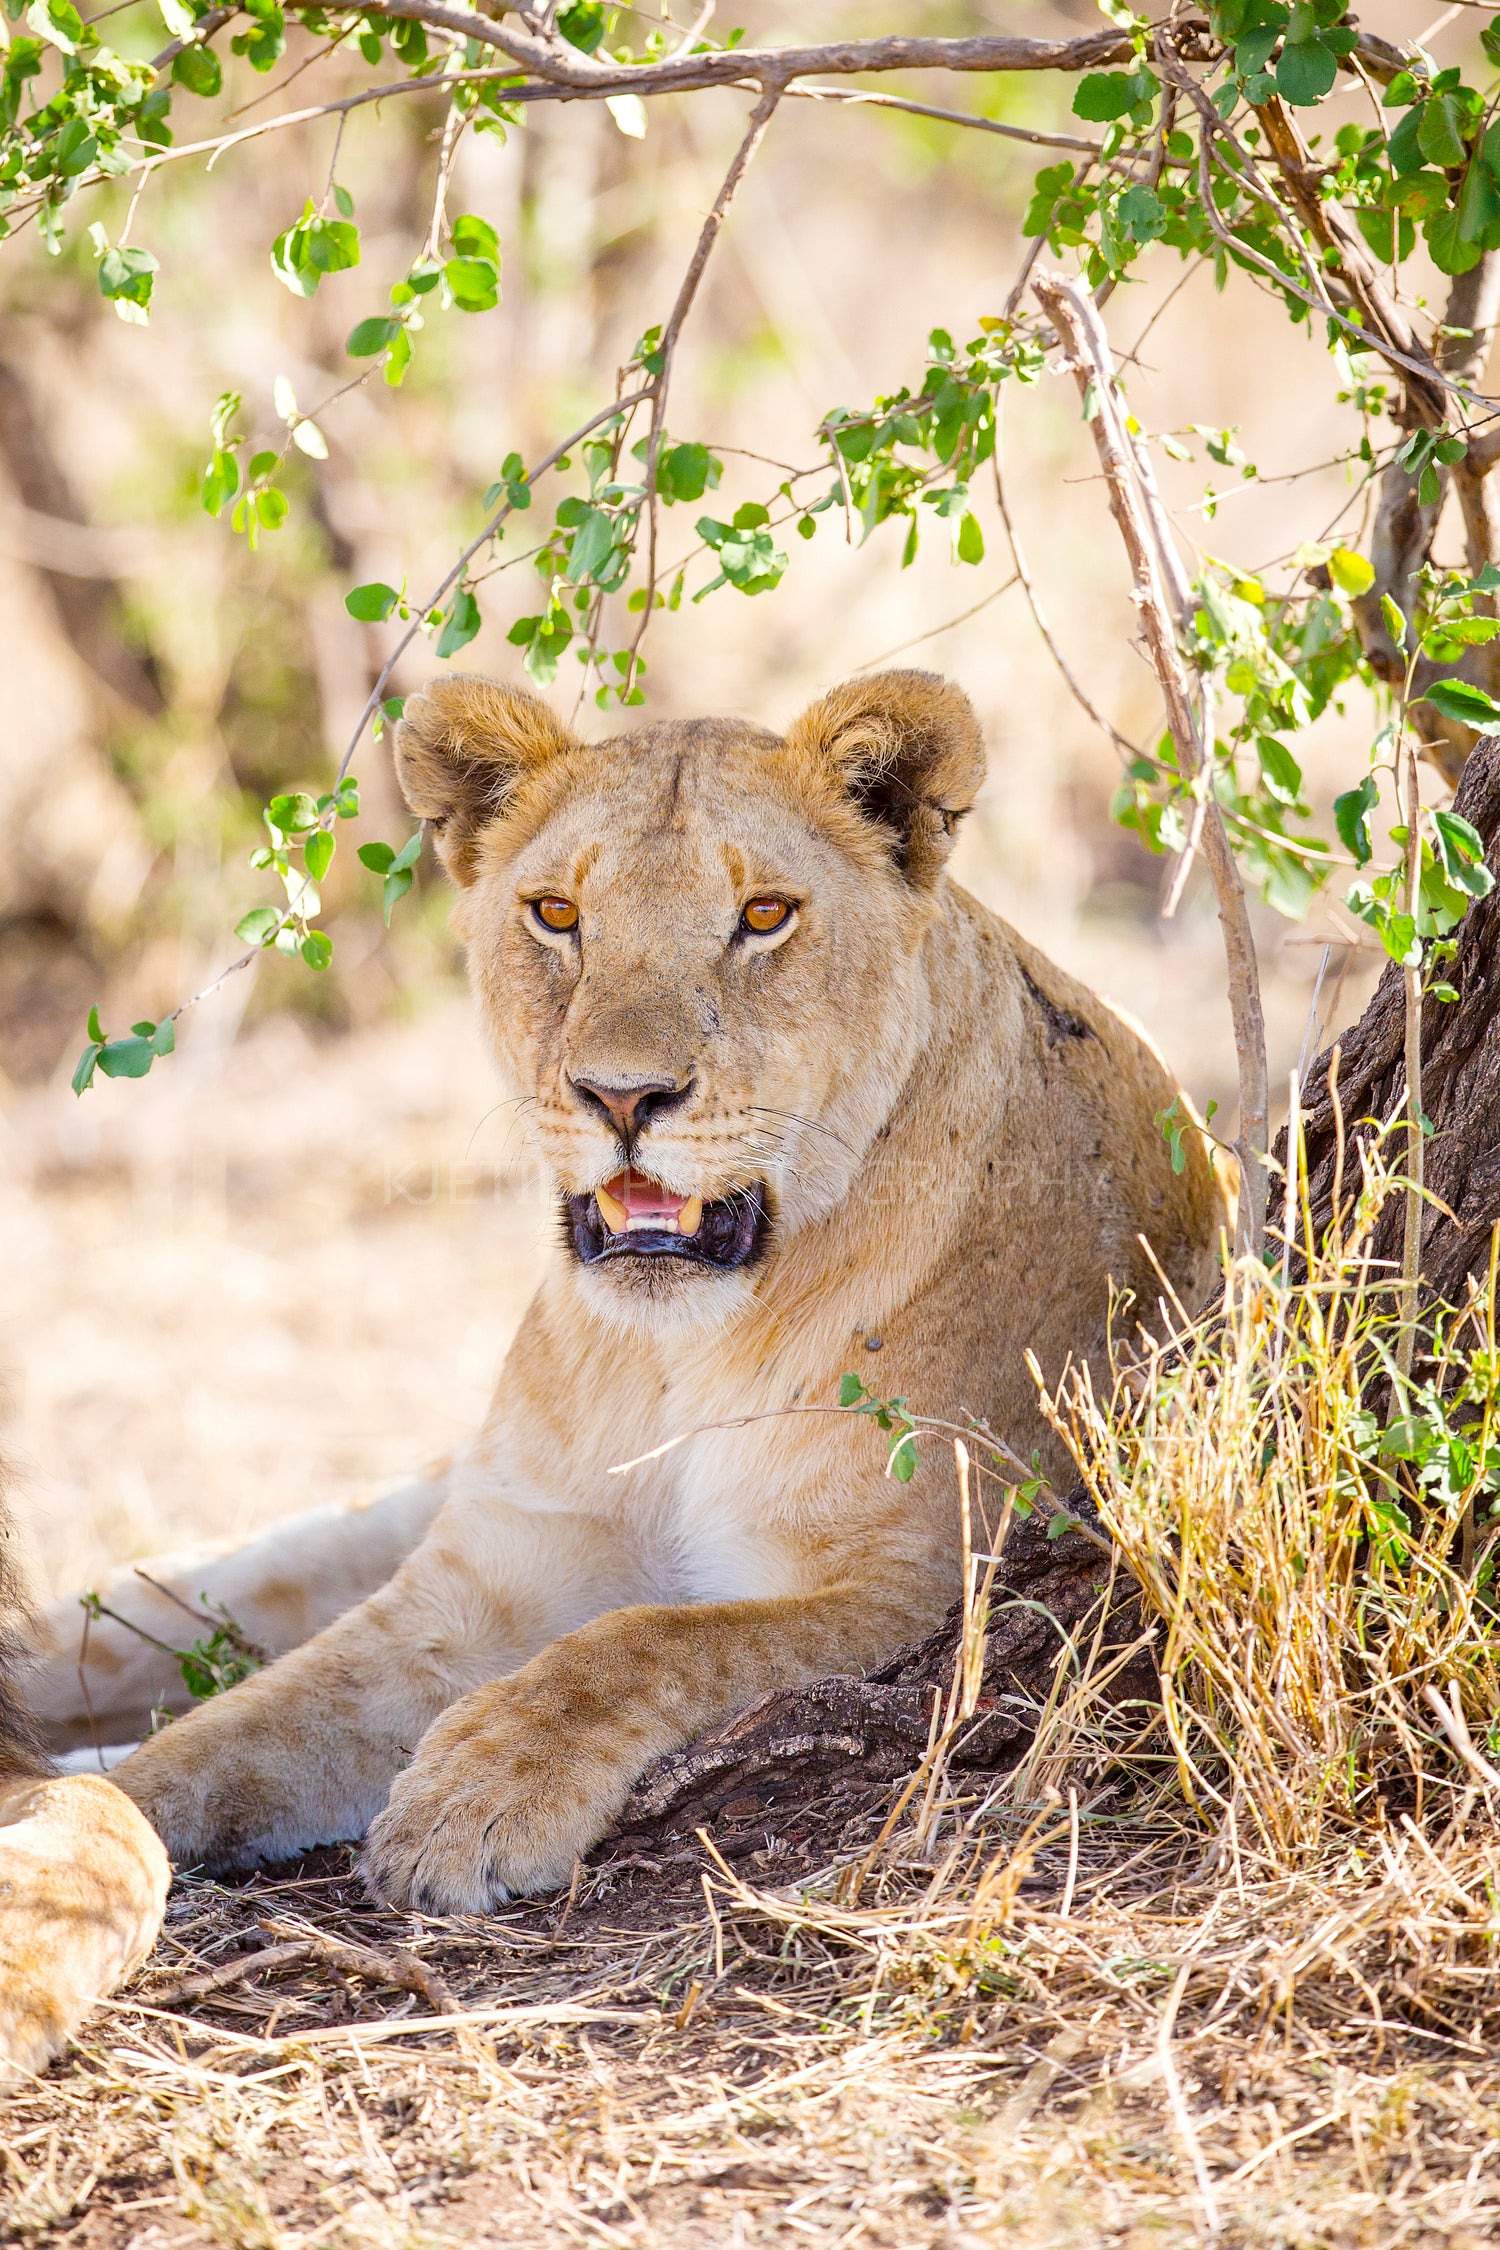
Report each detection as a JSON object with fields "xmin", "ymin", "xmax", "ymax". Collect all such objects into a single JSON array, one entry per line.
[{"xmin": 362, "ymin": 1683, "xmax": 634, "ymax": 1915}]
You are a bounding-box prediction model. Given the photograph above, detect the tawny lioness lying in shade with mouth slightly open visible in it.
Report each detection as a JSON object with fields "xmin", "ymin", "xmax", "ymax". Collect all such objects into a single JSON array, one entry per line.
[{"xmin": 46, "ymin": 673, "xmax": 1219, "ymax": 1913}]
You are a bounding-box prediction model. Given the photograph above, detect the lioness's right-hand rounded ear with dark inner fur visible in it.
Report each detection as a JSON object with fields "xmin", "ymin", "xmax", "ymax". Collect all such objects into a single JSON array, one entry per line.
[{"xmin": 787, "ymin": 673, "xmax": 985, "ymax": 884}]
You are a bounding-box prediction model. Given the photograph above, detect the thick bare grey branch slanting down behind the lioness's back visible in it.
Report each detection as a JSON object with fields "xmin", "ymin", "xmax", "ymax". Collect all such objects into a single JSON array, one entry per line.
[{"xmin": 1032, "ymin": 272, "xmax": 1271, "ymax": 1253}]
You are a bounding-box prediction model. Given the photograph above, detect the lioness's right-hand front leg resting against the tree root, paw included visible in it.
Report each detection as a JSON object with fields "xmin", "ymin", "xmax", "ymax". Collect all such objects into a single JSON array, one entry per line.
[{"xmin": 364, "ymin": 1586, "xmax": 936, "ymax": 1915}]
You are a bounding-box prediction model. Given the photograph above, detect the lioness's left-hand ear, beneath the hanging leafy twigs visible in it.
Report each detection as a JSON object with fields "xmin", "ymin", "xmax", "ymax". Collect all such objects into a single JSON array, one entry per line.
[{"xmin": 396, "ymin": 673, "xmax": 576, "ymax": 884}]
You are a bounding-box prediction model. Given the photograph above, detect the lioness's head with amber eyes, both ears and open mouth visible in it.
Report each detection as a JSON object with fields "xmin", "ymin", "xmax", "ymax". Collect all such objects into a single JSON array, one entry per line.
[{"xmin": 396, "ymin": 673, "xmax": 983, "ymax": 1328}]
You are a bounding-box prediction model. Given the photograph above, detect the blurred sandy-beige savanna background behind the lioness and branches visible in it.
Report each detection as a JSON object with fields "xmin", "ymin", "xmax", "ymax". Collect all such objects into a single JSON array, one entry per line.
[{"xmin": 0, "ymin": 0, "xmax": 1482, "ymax": 1589}]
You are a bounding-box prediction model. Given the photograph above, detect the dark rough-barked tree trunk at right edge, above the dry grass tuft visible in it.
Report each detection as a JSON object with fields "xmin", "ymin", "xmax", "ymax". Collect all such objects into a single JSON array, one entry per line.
[{"xmin": 1277, "ymin": 736, "xmax": 1500, "ymax": 1305}]
